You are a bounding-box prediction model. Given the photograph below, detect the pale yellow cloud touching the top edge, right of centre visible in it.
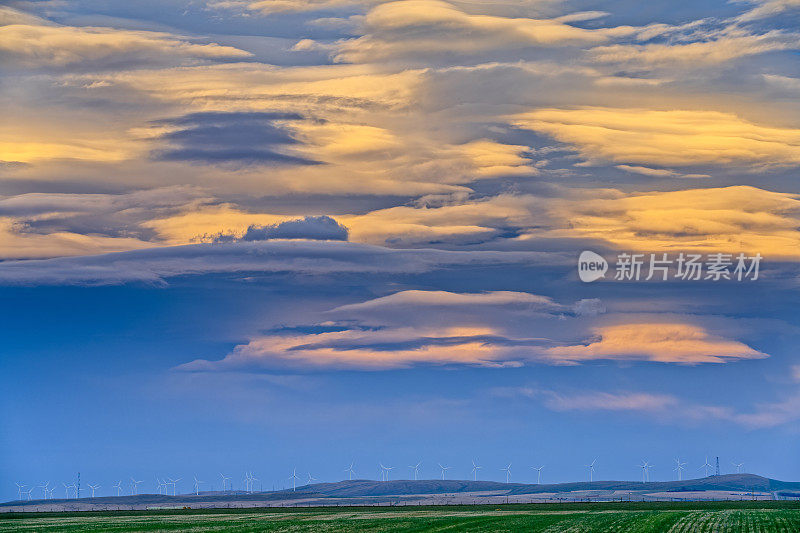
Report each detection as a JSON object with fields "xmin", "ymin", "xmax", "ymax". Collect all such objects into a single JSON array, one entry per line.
[{"xmin": 334, "ymin": 0, "xmax": 635, "ymax": 63}]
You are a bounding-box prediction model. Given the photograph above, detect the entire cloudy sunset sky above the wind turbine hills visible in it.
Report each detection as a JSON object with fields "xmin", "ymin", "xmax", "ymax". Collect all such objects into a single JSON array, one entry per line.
[{"xmin": 0, "ymin": 0, "xmax": 800, "ymax": 500}]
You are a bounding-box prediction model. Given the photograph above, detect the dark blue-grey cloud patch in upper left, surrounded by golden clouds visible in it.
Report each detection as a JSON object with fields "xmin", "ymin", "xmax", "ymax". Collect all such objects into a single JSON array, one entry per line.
[{"xmin": 152, "ymin": 112, "xmax": 319, "ymax": 166}]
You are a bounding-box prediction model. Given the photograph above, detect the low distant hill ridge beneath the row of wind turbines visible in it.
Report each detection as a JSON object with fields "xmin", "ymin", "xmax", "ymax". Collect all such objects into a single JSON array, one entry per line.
[{"xmin": 0, "ymin": 474, "xmax": 800, "ymax": 507}]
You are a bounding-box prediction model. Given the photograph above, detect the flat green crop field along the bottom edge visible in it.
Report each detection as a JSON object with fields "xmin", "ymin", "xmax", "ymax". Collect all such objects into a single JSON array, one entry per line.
[{"xmin": 0, "ymin": 502, "xmax": 800, "ymax": 533}]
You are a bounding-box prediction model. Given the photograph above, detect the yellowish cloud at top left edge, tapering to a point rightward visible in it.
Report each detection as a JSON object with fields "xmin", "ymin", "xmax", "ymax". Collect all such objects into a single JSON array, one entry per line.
[{"xmin": 0, "ymin": 10, "xmax": 251, "ymax": 68}]
